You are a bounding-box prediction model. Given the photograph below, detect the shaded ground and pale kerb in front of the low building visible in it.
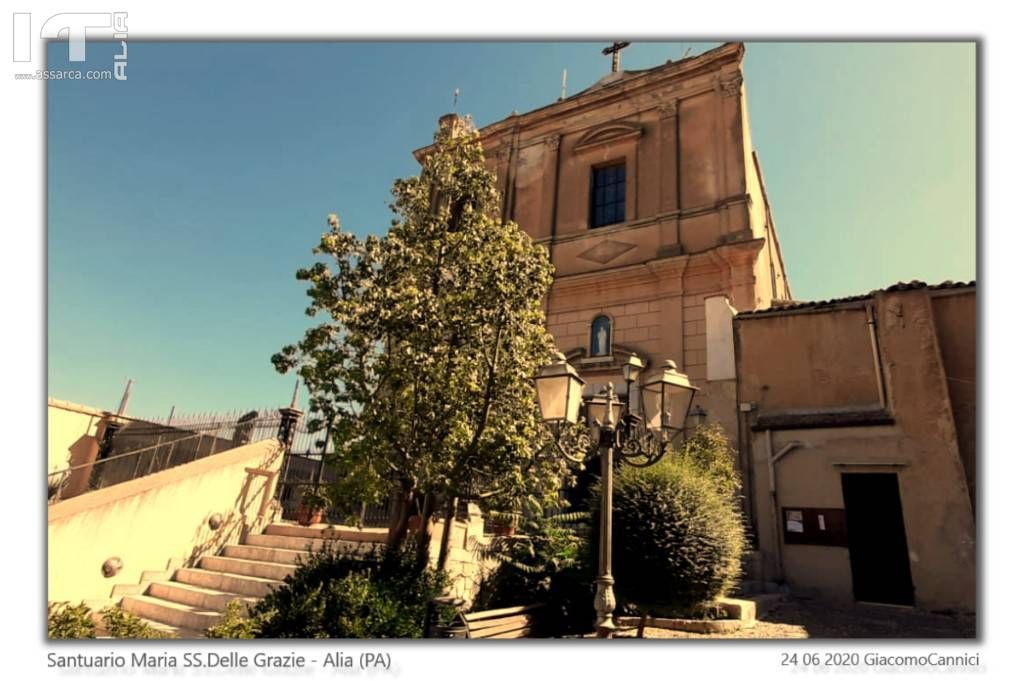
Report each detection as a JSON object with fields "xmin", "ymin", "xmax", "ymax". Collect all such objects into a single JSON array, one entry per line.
[{"xmin": 606, "ymin": 598, "xmax": 975, "ymax": 639}]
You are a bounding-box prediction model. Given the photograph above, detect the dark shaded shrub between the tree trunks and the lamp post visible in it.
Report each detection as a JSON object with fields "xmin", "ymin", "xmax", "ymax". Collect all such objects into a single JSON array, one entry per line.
[{"xmin": 474, "ymin": 503, "xmax": 594, "ymax": 636}]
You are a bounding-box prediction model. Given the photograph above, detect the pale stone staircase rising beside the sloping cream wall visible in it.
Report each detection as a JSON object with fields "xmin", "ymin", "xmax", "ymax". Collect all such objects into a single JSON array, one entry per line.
[{"xmin": 121, "ymin": 522, "xmax": 387, "ymax": 638}]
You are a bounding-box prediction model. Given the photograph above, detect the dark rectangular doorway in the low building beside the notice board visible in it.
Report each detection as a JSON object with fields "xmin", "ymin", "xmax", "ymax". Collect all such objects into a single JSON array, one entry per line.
[{"xmin": 843, "ymin": 473, "xmax": 913, "ymax": 605}]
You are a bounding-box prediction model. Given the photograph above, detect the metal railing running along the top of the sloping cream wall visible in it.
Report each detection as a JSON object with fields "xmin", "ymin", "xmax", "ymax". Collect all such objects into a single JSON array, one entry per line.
[{"xmin": 47, "ymin": 410, "xmax": 282, "ymax": 504}]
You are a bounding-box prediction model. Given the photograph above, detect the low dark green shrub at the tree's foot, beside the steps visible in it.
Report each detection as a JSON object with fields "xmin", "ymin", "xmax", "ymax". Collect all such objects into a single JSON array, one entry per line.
[{"xmin": 241, "ymin": 546, "xmax": 446, "ymax": 638}]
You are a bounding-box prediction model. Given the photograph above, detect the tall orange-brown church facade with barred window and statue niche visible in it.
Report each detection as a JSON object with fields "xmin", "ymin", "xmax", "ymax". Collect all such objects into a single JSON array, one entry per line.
[{"xmin": 417, "ymin": 43, "xmax": 791, "ymax": 438}]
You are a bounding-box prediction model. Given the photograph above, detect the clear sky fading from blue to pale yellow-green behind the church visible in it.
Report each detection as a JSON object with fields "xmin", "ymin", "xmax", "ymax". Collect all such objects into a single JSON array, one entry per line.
[{"xmin": 47, "ymin": 42, "xmax": 976, "ymax": 416}]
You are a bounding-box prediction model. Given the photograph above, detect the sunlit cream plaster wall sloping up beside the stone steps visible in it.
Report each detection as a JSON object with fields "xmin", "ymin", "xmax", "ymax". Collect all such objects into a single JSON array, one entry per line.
[{"xmin": 47, "ymin": 439, "xmax": 283, "ymax": 603}]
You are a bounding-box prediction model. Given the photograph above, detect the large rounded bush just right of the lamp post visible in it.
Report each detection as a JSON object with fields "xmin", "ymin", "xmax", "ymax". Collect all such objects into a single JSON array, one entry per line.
[{"xmin": 594, "ymin": 428, "xmax": 746, "ymax": 616}]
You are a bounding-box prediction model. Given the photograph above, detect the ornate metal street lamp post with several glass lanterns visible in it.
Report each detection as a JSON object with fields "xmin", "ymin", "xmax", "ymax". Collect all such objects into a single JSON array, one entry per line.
[{"xmin": 536, "ymin": 352, "xmax": 698, "ymax": 638}]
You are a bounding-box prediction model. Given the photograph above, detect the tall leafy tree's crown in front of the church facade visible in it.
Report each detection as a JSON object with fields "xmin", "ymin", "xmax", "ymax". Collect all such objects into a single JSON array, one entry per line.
[{"xmin": 272, "ymin": 119, "xmax": 567, "ymax": 557}]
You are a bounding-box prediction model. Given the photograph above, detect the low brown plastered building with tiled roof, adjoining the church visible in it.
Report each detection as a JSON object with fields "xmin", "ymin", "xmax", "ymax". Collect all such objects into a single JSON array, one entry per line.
[{"xmin": 734, "ymin": 283, "xmax": 976, "ymax": 611}]
